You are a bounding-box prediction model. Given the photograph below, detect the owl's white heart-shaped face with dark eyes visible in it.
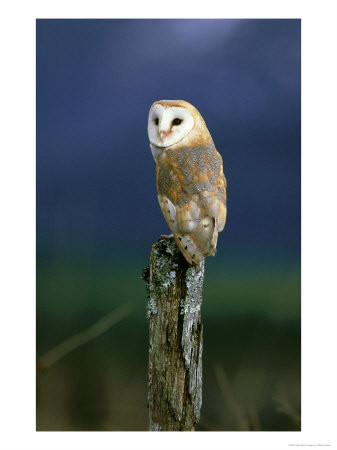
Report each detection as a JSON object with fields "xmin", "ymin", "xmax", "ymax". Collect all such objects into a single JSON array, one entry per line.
[{"xmin": 147, "ymin": 104, "xmax": 194, "ymax": 147}]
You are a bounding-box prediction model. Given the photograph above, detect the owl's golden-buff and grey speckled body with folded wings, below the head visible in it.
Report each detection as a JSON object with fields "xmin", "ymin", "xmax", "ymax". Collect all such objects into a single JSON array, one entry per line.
[{"xmin": 157, "ymin": 149, "xmax": 227, "ymax": 264}]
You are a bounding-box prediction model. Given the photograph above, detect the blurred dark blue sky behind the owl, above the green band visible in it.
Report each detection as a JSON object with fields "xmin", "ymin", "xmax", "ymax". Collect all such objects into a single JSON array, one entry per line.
[{"xmin": 37, "ymin": 19, "xmax": 301, "ymax": 264}]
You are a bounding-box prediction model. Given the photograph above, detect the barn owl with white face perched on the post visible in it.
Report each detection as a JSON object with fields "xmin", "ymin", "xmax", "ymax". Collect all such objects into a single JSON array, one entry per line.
[{"xmin": 148, "ymin": 100, "xmax": 227, "ymax": 265}]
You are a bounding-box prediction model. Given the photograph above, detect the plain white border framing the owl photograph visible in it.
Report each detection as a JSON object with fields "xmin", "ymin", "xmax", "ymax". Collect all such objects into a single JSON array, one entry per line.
[{"xmin": 0, "ymin": 0, "xmax": 337, "ymax": 450}]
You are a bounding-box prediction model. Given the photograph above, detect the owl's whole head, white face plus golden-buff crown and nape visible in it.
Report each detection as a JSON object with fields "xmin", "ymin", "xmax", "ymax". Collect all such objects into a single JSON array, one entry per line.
[{"xmin": 147, "ymin": 100, "xmax": 209, "ymax": 148}]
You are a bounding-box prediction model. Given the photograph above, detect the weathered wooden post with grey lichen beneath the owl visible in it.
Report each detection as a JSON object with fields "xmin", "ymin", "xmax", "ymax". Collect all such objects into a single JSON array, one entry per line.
[{"xmin": 143, "ymin": 237, "xmax": 205, "ymax": 431}]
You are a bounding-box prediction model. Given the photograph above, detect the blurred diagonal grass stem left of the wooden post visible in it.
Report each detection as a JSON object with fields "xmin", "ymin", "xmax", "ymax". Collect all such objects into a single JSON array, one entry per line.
[{"xmin": 37, "ymin": 305, "xmax": 132, "ymax": 372}]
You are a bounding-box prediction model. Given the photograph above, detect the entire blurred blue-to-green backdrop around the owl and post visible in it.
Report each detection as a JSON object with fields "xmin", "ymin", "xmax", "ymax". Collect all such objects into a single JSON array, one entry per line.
[{"xmin": 36, "ymin": 19, "xmax": 301, "ymax": 431}]
